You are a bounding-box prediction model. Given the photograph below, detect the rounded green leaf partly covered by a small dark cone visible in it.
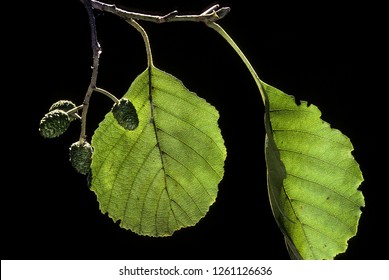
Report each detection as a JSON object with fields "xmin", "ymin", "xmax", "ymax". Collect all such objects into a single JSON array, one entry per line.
[{"xmin": 91, "ymin": 66, "xmax": 226, "ymax": 236}]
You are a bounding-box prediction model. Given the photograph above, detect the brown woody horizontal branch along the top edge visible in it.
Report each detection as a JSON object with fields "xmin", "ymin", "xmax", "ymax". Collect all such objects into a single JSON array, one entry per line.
[{"xmin": 90, "ymin": 0, "xmax": 231, "ymax": 23}]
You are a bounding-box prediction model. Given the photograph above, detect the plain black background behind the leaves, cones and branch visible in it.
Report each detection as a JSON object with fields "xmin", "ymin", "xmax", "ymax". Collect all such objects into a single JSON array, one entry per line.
[{"xmin": 1, "ymin": 0, "xmax": 388, "ymax": 259}]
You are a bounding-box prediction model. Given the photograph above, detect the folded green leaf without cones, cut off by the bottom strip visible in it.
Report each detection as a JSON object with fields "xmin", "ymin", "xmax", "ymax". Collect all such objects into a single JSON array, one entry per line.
[{"xmin": 263, "ymin": 83, "xmax": 364, "ymax": 259}]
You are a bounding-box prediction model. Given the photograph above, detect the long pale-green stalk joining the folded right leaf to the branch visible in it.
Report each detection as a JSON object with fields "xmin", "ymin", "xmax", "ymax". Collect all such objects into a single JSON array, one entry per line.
[{"xmin": 205, "ymin": 22, "xmax": 266, "ymax": 104}]
